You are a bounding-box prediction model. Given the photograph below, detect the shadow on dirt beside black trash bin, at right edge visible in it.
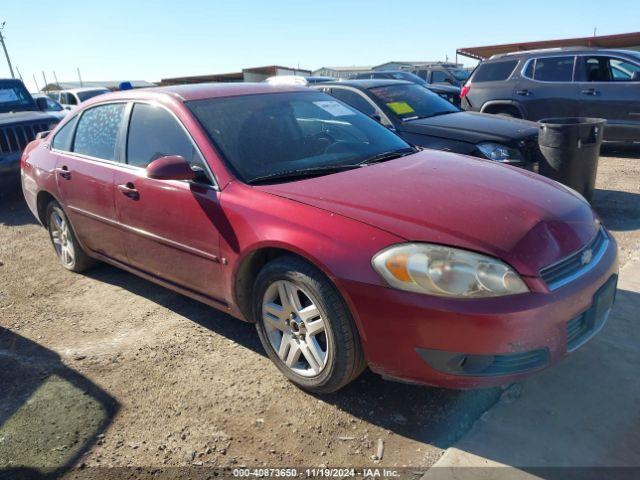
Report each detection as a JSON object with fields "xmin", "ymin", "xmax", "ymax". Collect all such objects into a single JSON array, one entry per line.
[{"xmin": 591, "ymin": 189, "xmax": 640, "ymax": 231}]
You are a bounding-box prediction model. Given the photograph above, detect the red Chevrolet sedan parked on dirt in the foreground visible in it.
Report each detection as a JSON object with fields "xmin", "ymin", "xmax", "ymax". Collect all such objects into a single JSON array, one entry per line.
[{"xmin": 22, "ymin": 84, "xmax": 617, "ymax": 393}]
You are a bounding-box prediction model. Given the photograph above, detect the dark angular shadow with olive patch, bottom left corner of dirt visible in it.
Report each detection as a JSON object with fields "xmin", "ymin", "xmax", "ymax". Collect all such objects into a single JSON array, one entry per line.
[{"xmin": 0, "ymin": 327, "xmax": 119, "ymax": 480}]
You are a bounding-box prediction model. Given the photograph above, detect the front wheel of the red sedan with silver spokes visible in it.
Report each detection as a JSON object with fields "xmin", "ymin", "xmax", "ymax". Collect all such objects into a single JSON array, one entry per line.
[{"xmin": 253, "ymin": 255, "xmax": 366, "ymax": 394}]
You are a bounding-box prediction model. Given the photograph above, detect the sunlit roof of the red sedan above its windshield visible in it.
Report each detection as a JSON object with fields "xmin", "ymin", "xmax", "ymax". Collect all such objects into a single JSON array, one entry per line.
[{"xmin": 86, "ymin": 82, "xmax": 309, "ymax": 104}]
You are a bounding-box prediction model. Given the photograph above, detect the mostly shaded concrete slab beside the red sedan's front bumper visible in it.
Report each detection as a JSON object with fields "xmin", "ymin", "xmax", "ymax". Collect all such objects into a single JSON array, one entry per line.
[{"xmin": 440, "ymin": 286, "xmax": 640, "ymax": 480}]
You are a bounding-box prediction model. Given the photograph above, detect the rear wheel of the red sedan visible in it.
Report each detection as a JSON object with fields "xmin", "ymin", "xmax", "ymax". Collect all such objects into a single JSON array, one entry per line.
[{"xmin": 46, "ymin": 200, "xmax": 95, "ymax": 273}]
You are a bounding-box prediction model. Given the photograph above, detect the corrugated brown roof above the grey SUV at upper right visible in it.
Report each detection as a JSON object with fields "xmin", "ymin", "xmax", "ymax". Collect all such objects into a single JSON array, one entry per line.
[{"xmin": 456, "ymin": 32, "xmax": 640, "ymax": 60}]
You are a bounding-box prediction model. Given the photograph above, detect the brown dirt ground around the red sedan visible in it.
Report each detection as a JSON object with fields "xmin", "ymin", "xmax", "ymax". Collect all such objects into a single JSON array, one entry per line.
[{"xmin": 0, "ymin": 146, "xmax": 640, "ymax": 473}]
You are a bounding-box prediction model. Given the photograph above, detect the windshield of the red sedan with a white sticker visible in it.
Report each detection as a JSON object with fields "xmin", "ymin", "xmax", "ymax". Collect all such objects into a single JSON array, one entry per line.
[{"xmin": 187, "ymin": 91, "xmax": 412, "ymax": 183}]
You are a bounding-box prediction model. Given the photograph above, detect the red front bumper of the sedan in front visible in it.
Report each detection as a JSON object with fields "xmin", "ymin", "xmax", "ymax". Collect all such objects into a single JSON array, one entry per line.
[{"xmin": 343, "ymin": 234, "xmax": 618, "ymax": 388}]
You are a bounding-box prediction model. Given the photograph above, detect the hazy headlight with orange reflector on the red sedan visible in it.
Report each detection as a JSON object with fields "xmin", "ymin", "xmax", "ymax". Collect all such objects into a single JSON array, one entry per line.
[{"xmin": 371, "ymin": 243, "xmax": 529, "ymax": 298}]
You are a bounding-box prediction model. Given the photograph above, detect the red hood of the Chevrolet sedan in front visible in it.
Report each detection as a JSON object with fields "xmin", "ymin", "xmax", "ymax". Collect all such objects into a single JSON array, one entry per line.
[{"xmin": 255, "ymin": 151, "xmax": 598, "ymax": 276}]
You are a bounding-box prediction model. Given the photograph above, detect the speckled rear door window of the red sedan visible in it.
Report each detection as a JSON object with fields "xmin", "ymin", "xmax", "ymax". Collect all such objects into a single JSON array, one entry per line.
[{"xmin": 73, "ymin": 103, "xmax": 125, "ymax": 161}]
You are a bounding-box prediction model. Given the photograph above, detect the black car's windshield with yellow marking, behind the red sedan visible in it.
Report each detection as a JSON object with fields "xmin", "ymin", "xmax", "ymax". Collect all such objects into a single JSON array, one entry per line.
[{"xmin": 369, "ymin": 84, "xmax": 459, "ymax": 121}]
